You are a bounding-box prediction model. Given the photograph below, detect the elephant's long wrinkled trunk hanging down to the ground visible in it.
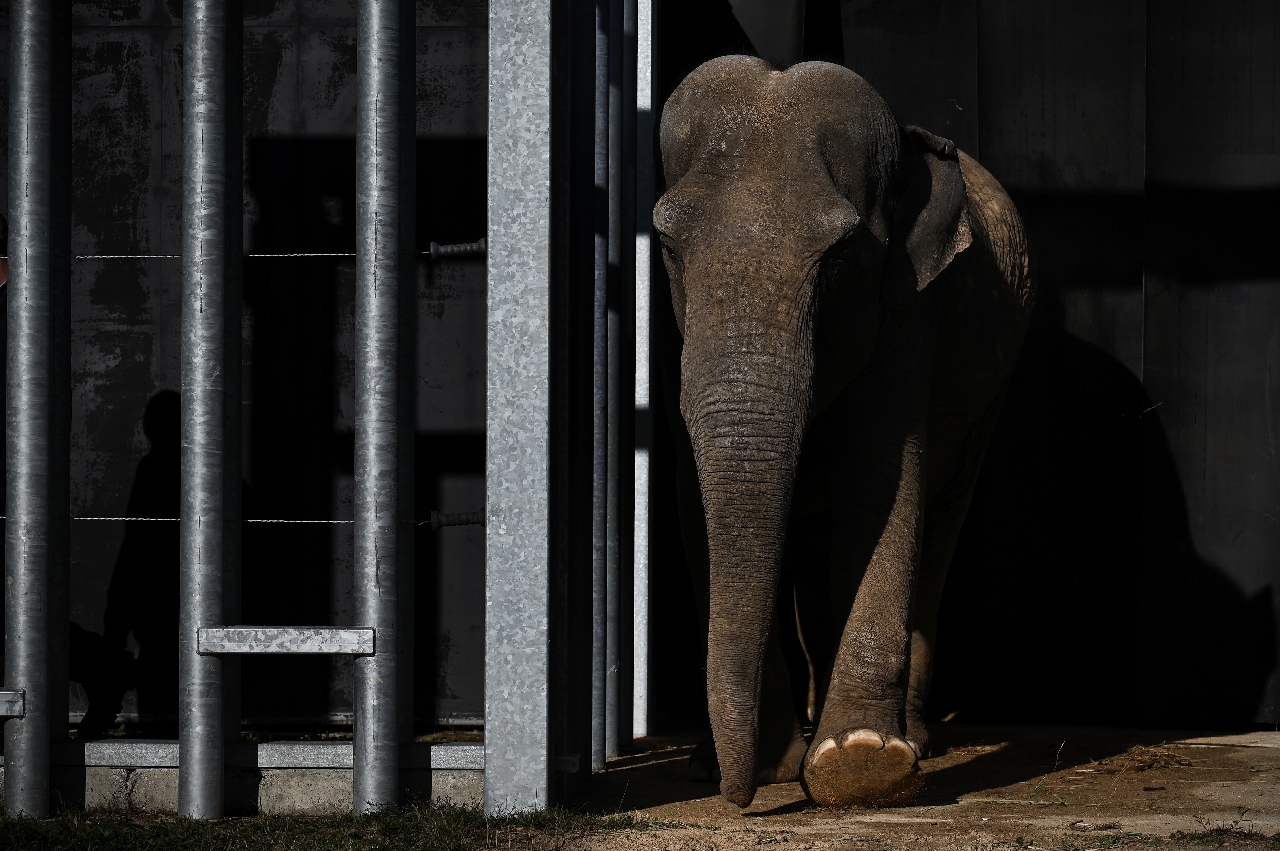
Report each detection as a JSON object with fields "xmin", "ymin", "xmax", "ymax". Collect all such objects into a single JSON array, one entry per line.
[{"xmin": 681, "ymin": 322, "xmax": 813, "ymax": 806}]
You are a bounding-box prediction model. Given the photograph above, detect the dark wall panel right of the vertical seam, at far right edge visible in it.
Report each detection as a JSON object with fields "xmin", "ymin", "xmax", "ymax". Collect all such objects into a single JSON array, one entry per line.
[{"xmin": 1140, "ymin": 0, "xmax": 1280, "ymax": 724}]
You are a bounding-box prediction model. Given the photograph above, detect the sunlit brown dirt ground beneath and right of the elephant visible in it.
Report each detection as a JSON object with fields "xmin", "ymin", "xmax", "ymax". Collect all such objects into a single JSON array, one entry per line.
[{"xmin": 575, "ymin": 724, "xmax": 1280, "ymax": 851}]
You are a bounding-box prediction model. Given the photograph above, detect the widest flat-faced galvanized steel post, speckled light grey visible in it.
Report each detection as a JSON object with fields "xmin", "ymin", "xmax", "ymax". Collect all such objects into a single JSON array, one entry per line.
[{"xmin": 484, "ymin": 0, "xmax": 553, "ymax": 815}]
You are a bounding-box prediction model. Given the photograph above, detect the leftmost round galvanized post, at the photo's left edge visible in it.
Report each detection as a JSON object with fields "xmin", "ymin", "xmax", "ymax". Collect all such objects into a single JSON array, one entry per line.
[{"xmin": 4, "ymin": 0, "xmax": 70, "ymax": 818}]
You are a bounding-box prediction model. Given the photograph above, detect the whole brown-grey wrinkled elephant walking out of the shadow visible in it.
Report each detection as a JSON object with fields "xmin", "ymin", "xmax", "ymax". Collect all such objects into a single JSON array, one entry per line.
[{"xmin": 654, "ymin": 56, "xmax": 1032, "ymax": 806}]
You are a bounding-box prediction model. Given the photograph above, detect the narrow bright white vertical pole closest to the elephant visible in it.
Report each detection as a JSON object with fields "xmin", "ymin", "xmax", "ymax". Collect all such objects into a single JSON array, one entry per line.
[{"xmin": 627, "ymin": 0, "xmax": 655, "ymax": 736}]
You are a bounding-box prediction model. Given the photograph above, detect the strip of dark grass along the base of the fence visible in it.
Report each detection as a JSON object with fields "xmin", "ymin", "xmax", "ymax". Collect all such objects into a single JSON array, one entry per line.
[{"xmin": 0, "ymin": 806, "xmax": 675, "ymax": 851}]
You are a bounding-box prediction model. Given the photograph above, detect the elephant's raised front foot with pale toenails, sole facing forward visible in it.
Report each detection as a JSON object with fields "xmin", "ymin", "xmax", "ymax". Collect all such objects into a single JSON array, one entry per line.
[{"xmin": 801, "ymin": 729, "xmax": 924, "ymax": 806}]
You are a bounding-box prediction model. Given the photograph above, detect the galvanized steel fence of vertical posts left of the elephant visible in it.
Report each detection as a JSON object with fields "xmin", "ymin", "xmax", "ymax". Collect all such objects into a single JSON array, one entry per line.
[{"xmin": 0, "ymin": 0, "xmax": 653, "ymax": 819}]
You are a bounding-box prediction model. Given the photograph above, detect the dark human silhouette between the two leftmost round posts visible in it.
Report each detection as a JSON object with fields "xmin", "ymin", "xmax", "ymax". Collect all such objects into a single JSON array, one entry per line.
[{"xmin": 102, "ymin": 390, "xmax": 182, "ymax": 737}]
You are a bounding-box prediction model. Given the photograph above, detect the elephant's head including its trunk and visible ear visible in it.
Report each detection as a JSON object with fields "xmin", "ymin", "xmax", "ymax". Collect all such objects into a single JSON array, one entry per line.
[{"xmin": 654, "ymin": 56, "xmax": 969, "ymax": 806}]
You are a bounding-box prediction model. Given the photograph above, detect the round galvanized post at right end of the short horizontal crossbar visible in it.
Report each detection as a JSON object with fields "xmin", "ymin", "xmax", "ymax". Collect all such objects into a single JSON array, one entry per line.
[{"xmin": 353, "ymin": 0, "xmax": 415, "ymax": 813}]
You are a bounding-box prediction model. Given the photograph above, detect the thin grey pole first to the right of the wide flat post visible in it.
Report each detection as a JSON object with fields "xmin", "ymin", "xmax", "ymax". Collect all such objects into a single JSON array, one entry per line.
[{"xmin": 591, "ymin": 0, "xmax": 613, "ymax": 772}]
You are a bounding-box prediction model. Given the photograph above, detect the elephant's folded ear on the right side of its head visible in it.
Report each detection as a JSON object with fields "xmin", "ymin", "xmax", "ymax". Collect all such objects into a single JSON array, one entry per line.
[{"xmin": 886, "ymin": 127, "xmax": 973, "ymax": 290}]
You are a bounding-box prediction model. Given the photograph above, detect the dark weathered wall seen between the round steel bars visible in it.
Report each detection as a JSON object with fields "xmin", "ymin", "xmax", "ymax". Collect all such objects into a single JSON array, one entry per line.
[{"xmin": 0, "ymin": 0, "xmax": 488, "ymax": 720}]
